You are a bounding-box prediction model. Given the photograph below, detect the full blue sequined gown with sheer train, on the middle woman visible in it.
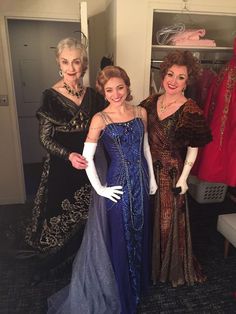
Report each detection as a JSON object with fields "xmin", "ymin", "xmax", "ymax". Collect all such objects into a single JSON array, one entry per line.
[{"xmin": 48, "ymin": 113, "xmax": 150, "ymax": 314}]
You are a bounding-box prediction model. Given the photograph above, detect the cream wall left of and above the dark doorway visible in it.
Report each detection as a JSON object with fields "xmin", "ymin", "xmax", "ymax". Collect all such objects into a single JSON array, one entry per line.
[{"xmin": 0, "ymin": 0, "xmax": 107, "ymax": 204}]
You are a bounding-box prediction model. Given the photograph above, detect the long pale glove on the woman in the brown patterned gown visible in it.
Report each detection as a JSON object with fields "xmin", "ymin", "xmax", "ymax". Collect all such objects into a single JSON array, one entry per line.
[{"xmin": 176, "ymin": 146, "xmax": 198, "ymax": 194}]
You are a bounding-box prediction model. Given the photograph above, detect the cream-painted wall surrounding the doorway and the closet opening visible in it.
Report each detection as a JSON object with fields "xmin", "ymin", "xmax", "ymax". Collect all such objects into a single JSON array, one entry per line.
[{"xmin": 0, "ymin": 0, "xmax": 236, "ymax": 204}]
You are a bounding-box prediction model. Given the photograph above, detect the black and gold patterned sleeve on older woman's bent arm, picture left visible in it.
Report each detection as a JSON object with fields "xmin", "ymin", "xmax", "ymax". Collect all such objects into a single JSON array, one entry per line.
[{"xmin": 39, "ymin": 116, "xmax": 71, "ymax": 160}]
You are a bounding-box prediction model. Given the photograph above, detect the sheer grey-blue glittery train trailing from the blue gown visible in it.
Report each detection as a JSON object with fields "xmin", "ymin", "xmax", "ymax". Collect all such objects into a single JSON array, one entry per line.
[{"xmin": 48, "ymin": 144, "xmax": 120, "ymax": 314}]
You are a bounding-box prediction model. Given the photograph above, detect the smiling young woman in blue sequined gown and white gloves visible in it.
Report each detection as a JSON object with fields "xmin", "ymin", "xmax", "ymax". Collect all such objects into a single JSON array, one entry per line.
[{"xmin": 48, "ymin": 66, "xmax": 157, "ymax": 314}]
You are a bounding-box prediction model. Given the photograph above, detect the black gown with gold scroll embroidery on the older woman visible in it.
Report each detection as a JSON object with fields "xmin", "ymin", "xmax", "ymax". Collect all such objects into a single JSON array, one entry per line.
[{"xmin": 25, "ymin": 88, "xmax": 104, "ymax": 263}]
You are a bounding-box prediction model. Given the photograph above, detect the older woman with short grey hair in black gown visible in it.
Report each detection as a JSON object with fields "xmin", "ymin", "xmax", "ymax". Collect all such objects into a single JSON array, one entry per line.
[{"xmin": 25, "ymin": 38, "xmax": 105, "ymax": 280}]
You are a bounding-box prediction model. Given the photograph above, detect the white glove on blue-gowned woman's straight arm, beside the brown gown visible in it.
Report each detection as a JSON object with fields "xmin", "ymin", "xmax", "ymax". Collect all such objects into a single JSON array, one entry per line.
[{"xmin": 143, "ymin": 132, "xmax": 158, "ymax": 195}]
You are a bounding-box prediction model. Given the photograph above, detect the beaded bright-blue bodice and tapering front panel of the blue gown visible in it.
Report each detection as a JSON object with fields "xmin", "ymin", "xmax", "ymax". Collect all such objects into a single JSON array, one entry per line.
[{"xmin": 101, "ymin": 117, "xmax": 149, "ymax": 303}]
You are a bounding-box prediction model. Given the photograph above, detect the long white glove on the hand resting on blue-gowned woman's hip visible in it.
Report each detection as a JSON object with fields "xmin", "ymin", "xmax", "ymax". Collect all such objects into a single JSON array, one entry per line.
[{"xmin": 83, "ymin": 142, "xmax": 123, "ymax": 203}]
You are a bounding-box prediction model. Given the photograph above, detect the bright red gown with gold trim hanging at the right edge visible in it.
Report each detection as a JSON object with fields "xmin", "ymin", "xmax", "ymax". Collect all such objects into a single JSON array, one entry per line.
[{"xmin": 192, "ymin": 38, "xmax": 236, "ymax": 186}]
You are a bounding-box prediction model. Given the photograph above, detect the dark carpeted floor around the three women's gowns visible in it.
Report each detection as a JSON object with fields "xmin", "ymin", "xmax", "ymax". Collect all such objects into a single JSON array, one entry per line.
[{"xmin": 0, "ymin": 163, "xmax": 236, "ymax": 314}]
